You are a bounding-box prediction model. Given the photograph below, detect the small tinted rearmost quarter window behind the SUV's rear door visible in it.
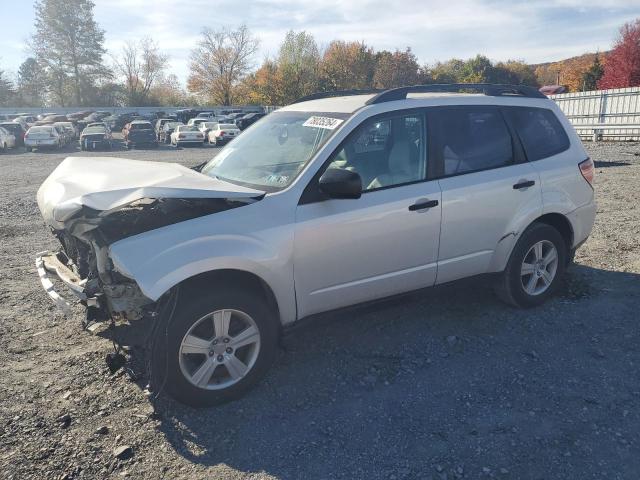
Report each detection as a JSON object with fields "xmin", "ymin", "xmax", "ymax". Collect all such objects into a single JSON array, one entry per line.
[{"xmin": 508, "ymin": 107, "xmax": 569, "ymax": 161}]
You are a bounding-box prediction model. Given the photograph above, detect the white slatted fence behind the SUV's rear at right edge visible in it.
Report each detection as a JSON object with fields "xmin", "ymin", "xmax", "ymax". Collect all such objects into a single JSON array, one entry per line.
[{"xmin": 550, "ymin": 87, "xmax": 640, "ymax": 141}]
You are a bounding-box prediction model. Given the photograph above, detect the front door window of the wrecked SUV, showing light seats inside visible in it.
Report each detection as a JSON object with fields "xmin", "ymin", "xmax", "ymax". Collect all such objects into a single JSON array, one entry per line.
[{"xmin": 328, "ymin": 114, "xmax": 426, "ymax": 191}]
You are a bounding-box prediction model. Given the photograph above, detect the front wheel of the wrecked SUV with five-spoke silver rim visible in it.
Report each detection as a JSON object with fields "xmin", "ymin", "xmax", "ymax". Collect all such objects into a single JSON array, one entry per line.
[{"xmin": 152, "ymin": 288, "xmax": 278, "ymax": 407}]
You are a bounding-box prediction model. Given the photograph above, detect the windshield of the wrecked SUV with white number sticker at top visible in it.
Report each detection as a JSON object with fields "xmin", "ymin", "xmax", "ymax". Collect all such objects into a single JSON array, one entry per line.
[{"xmin": 202, "ymin": 112, "xmax": 349, "ymax": 192}]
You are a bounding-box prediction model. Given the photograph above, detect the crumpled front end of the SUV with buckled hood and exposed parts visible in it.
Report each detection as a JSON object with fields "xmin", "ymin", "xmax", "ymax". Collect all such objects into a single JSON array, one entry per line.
[{"xmin": 36, "ymin": 157, "xmax": 265, "ymax": 320}]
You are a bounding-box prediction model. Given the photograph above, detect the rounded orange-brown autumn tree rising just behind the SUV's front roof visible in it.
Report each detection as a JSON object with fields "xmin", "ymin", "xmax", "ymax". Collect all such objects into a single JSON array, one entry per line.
[{"xmin": 319, "ymin": 40, "xmax": 376, "ymax": 90}]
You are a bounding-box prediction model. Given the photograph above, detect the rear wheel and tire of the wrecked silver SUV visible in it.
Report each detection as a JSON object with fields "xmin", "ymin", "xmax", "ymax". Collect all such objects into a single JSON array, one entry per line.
[{"xmin": 495, "ymin": 223, "xmax": 567, "ymax": 308}]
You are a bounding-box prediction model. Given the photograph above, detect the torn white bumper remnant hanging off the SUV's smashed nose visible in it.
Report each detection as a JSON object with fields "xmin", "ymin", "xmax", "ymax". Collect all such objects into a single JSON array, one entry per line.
[{"xmin": 36, "ymin": 252, "xmax": 90, "ymax": 316}]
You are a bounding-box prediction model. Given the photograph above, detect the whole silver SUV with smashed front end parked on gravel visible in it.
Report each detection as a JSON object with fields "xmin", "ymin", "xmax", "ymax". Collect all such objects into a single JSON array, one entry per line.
[{"xmin": 36, "ymin": 84, "xmax": 596, "ymax": 406}]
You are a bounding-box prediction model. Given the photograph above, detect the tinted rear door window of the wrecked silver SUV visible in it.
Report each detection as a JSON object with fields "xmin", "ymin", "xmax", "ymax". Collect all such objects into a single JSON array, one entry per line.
[{"xmin": 433, "ymin": 107, "xmax": 514, "ymax": 176}]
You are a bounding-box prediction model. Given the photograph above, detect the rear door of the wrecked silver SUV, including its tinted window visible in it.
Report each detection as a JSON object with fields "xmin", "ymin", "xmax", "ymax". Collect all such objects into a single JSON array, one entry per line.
[{"xmin": 429, "ymin": 106, "xmax": 542, "ymax": 283}]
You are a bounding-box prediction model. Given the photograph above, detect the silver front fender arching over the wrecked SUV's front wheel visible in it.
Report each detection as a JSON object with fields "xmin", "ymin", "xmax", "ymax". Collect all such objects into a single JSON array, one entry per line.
[{"xmin": 109, "ymin": 207, "xmax": 296, "ymax": 323}]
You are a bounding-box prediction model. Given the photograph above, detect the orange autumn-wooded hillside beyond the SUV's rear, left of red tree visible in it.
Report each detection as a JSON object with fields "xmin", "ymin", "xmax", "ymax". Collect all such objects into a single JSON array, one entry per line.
[{"xmin": 530, "ymin": 52, "xmax": 609, "ymax": 92}]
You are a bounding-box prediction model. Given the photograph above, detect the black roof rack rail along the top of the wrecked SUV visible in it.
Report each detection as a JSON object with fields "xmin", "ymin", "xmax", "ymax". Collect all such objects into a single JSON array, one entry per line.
[{"xmin": 367, "ymin": 83, "xmax": 547, "ymax": 105}]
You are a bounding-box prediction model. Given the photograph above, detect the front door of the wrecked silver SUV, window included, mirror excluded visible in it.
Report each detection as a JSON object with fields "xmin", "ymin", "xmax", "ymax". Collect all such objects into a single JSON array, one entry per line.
[{"xmin": 294, "ymin": 112, "xmax": 441, "ymax": 317}]
